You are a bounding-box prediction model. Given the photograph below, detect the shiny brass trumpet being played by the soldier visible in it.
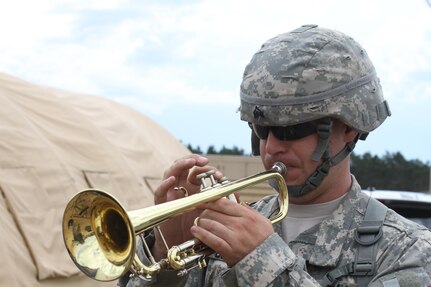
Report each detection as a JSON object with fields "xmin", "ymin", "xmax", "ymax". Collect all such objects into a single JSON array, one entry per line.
[{"xmin": 63, "ymin": 162, "xmax": 288, "ymax": 281}]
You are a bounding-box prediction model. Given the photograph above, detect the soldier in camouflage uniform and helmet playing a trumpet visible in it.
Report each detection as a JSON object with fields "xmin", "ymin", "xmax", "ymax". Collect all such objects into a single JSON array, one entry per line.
[{"xmin": 120, "ymin": 25, "xmax": 431, "ymax": 287}]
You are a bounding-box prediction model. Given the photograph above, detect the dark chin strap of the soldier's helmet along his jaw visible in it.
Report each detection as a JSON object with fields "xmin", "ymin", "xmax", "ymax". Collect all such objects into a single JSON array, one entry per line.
[{"xmin": 269, "ymin": 119, "xmax": 360, "ymax": 197}]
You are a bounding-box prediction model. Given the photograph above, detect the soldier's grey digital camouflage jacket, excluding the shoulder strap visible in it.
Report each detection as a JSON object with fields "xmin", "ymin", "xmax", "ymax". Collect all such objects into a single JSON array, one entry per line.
[{"xmin": 120, "ymin": 177, "xmax": 431, "ymax": 287}]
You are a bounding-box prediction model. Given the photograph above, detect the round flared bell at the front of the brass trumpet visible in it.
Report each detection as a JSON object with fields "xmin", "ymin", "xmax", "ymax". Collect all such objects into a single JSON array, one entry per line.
[{"xmin": 63, "ymin": 190, "xmax": 136, "ymax": 281}]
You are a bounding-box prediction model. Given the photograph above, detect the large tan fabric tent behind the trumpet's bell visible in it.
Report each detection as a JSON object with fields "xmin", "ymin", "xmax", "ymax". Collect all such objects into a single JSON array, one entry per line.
[{"xmin": 0, "ymin": 73, "xmax": 189, "ymax": 286}]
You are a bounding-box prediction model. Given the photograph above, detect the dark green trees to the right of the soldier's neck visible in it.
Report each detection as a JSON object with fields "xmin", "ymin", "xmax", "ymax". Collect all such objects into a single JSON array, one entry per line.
[{"xmin": 350, "ymin": 152, "xmax": 430, "ymax": 191}]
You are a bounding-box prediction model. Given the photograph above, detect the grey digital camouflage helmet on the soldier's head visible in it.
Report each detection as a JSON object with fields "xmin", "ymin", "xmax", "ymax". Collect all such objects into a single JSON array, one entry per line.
[{"xmin": 240, "ymin": 25, "xmax": 390, "ymax": 135}]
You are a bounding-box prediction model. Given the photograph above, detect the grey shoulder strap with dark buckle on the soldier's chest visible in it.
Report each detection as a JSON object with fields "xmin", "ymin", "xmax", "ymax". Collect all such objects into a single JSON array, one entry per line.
[{"xmin": 322, "ymin": 198, "xmax": 388, "ymax": 286}]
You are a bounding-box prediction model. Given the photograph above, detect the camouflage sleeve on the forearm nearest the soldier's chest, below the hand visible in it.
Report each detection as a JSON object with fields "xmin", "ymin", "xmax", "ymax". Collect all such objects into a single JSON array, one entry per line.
[{"xmin": 222, "ymin": 233, "xmax": 320, "ymax": 287}]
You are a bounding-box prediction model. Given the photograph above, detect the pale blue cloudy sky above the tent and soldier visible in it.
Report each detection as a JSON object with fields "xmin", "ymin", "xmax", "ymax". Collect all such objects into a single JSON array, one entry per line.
[{"xmin": 0, "ymin": 0, "xmax": 431, "ymax": 162}]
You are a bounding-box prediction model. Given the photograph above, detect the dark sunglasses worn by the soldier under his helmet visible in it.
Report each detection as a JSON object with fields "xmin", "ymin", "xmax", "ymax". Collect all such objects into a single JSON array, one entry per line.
[{"xmin": 249, "ymin": 122, "xmax": 317, "ymax": 141}]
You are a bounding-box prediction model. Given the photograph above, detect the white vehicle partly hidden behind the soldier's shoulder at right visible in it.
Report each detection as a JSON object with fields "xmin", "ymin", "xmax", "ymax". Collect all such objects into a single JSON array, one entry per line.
[{"xmin": 363, "ymin": 189, "xmax": 431, "ymax": 228}]
